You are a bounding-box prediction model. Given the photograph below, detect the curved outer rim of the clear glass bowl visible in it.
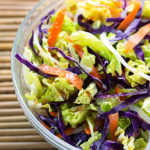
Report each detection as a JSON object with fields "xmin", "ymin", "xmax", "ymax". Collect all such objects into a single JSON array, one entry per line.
[{"xmin": 11, "ymin": 0, "xmax": 79, "ymax": 150}]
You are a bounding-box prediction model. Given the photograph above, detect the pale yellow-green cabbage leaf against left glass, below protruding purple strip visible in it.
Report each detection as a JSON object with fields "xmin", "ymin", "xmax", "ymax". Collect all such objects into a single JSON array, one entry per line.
[{"xmin": 25, "ymin": 71, "xmax": 43, "ymax": 100}]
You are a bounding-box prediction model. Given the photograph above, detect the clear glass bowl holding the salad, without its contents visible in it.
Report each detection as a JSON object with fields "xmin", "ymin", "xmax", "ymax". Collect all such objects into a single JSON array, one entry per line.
[{"xmin": 11, "ymin": 0, "xmax": 78, "ymax": 150}]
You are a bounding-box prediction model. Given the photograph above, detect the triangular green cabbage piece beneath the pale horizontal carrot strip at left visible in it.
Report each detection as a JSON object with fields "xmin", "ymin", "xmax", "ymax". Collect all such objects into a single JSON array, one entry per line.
[{"xmin": 40, "ymin": 84, "xmax": 64, "ymax": 103}]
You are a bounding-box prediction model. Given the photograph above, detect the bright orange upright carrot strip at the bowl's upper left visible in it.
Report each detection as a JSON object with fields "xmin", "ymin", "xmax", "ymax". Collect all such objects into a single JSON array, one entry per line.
[{"xmin": 48, "ymin": 9, "xmax": 66, "ymax": 47}]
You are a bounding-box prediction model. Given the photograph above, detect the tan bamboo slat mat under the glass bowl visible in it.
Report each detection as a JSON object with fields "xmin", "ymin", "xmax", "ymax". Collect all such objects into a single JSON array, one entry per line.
[{"xmin": 0, "ymin": 0, "xmax": 54, "ymax": 150}]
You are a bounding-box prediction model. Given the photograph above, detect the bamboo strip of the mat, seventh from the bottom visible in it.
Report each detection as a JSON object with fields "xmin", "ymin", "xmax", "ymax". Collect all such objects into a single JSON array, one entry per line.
[{"xmin": 0, "ymin": 101, "xmax": 20, "ymax": 109}]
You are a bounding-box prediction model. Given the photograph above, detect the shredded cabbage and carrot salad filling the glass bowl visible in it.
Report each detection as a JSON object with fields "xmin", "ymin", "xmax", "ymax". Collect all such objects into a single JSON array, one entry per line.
[{"xmin": 15, "ymin": 0, "xmax": 150, "ymax": 150}]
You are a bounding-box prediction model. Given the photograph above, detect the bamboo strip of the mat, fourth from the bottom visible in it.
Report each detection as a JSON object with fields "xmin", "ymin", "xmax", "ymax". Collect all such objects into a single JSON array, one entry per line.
[{"xmin": 0, "ymin": 122, "xmax": 32, "ymax": 129}]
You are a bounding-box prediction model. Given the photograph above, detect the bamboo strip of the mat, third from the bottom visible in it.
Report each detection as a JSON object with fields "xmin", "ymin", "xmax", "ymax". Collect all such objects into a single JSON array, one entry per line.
[{"xmin": 0, "ymin": 128, "xmax": 38, "ymax": 136}]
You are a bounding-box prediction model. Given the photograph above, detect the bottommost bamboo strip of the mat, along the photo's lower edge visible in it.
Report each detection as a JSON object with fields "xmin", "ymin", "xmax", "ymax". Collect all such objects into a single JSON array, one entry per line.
[{"xmin": 0, "ymin": 142, "xmax": 54, "ymax": 150}]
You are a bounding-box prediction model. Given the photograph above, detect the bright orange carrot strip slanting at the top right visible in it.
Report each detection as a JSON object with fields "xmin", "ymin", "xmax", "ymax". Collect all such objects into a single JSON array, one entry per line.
[{"xmin": 118, "ymin": 1, "xmax": 141, "ymax": 30}]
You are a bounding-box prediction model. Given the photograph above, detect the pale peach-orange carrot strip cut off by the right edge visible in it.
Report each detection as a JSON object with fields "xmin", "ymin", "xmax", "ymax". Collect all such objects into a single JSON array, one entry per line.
[{"xmin": 126, "ymin": 23, "xmax": 150, "ymax": 52}]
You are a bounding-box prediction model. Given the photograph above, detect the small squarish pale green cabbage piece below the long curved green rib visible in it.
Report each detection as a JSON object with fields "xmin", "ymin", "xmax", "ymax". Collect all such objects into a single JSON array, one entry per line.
[{"xmin": 80, "ymin": 48, "xmax": 95, "ymax": 73}]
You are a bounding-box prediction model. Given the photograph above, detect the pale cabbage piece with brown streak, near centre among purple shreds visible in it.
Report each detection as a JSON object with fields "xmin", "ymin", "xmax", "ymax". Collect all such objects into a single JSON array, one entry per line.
[{"xmin": 75, "ymin": 82, "xmax": 98, "ymax": 104}]
